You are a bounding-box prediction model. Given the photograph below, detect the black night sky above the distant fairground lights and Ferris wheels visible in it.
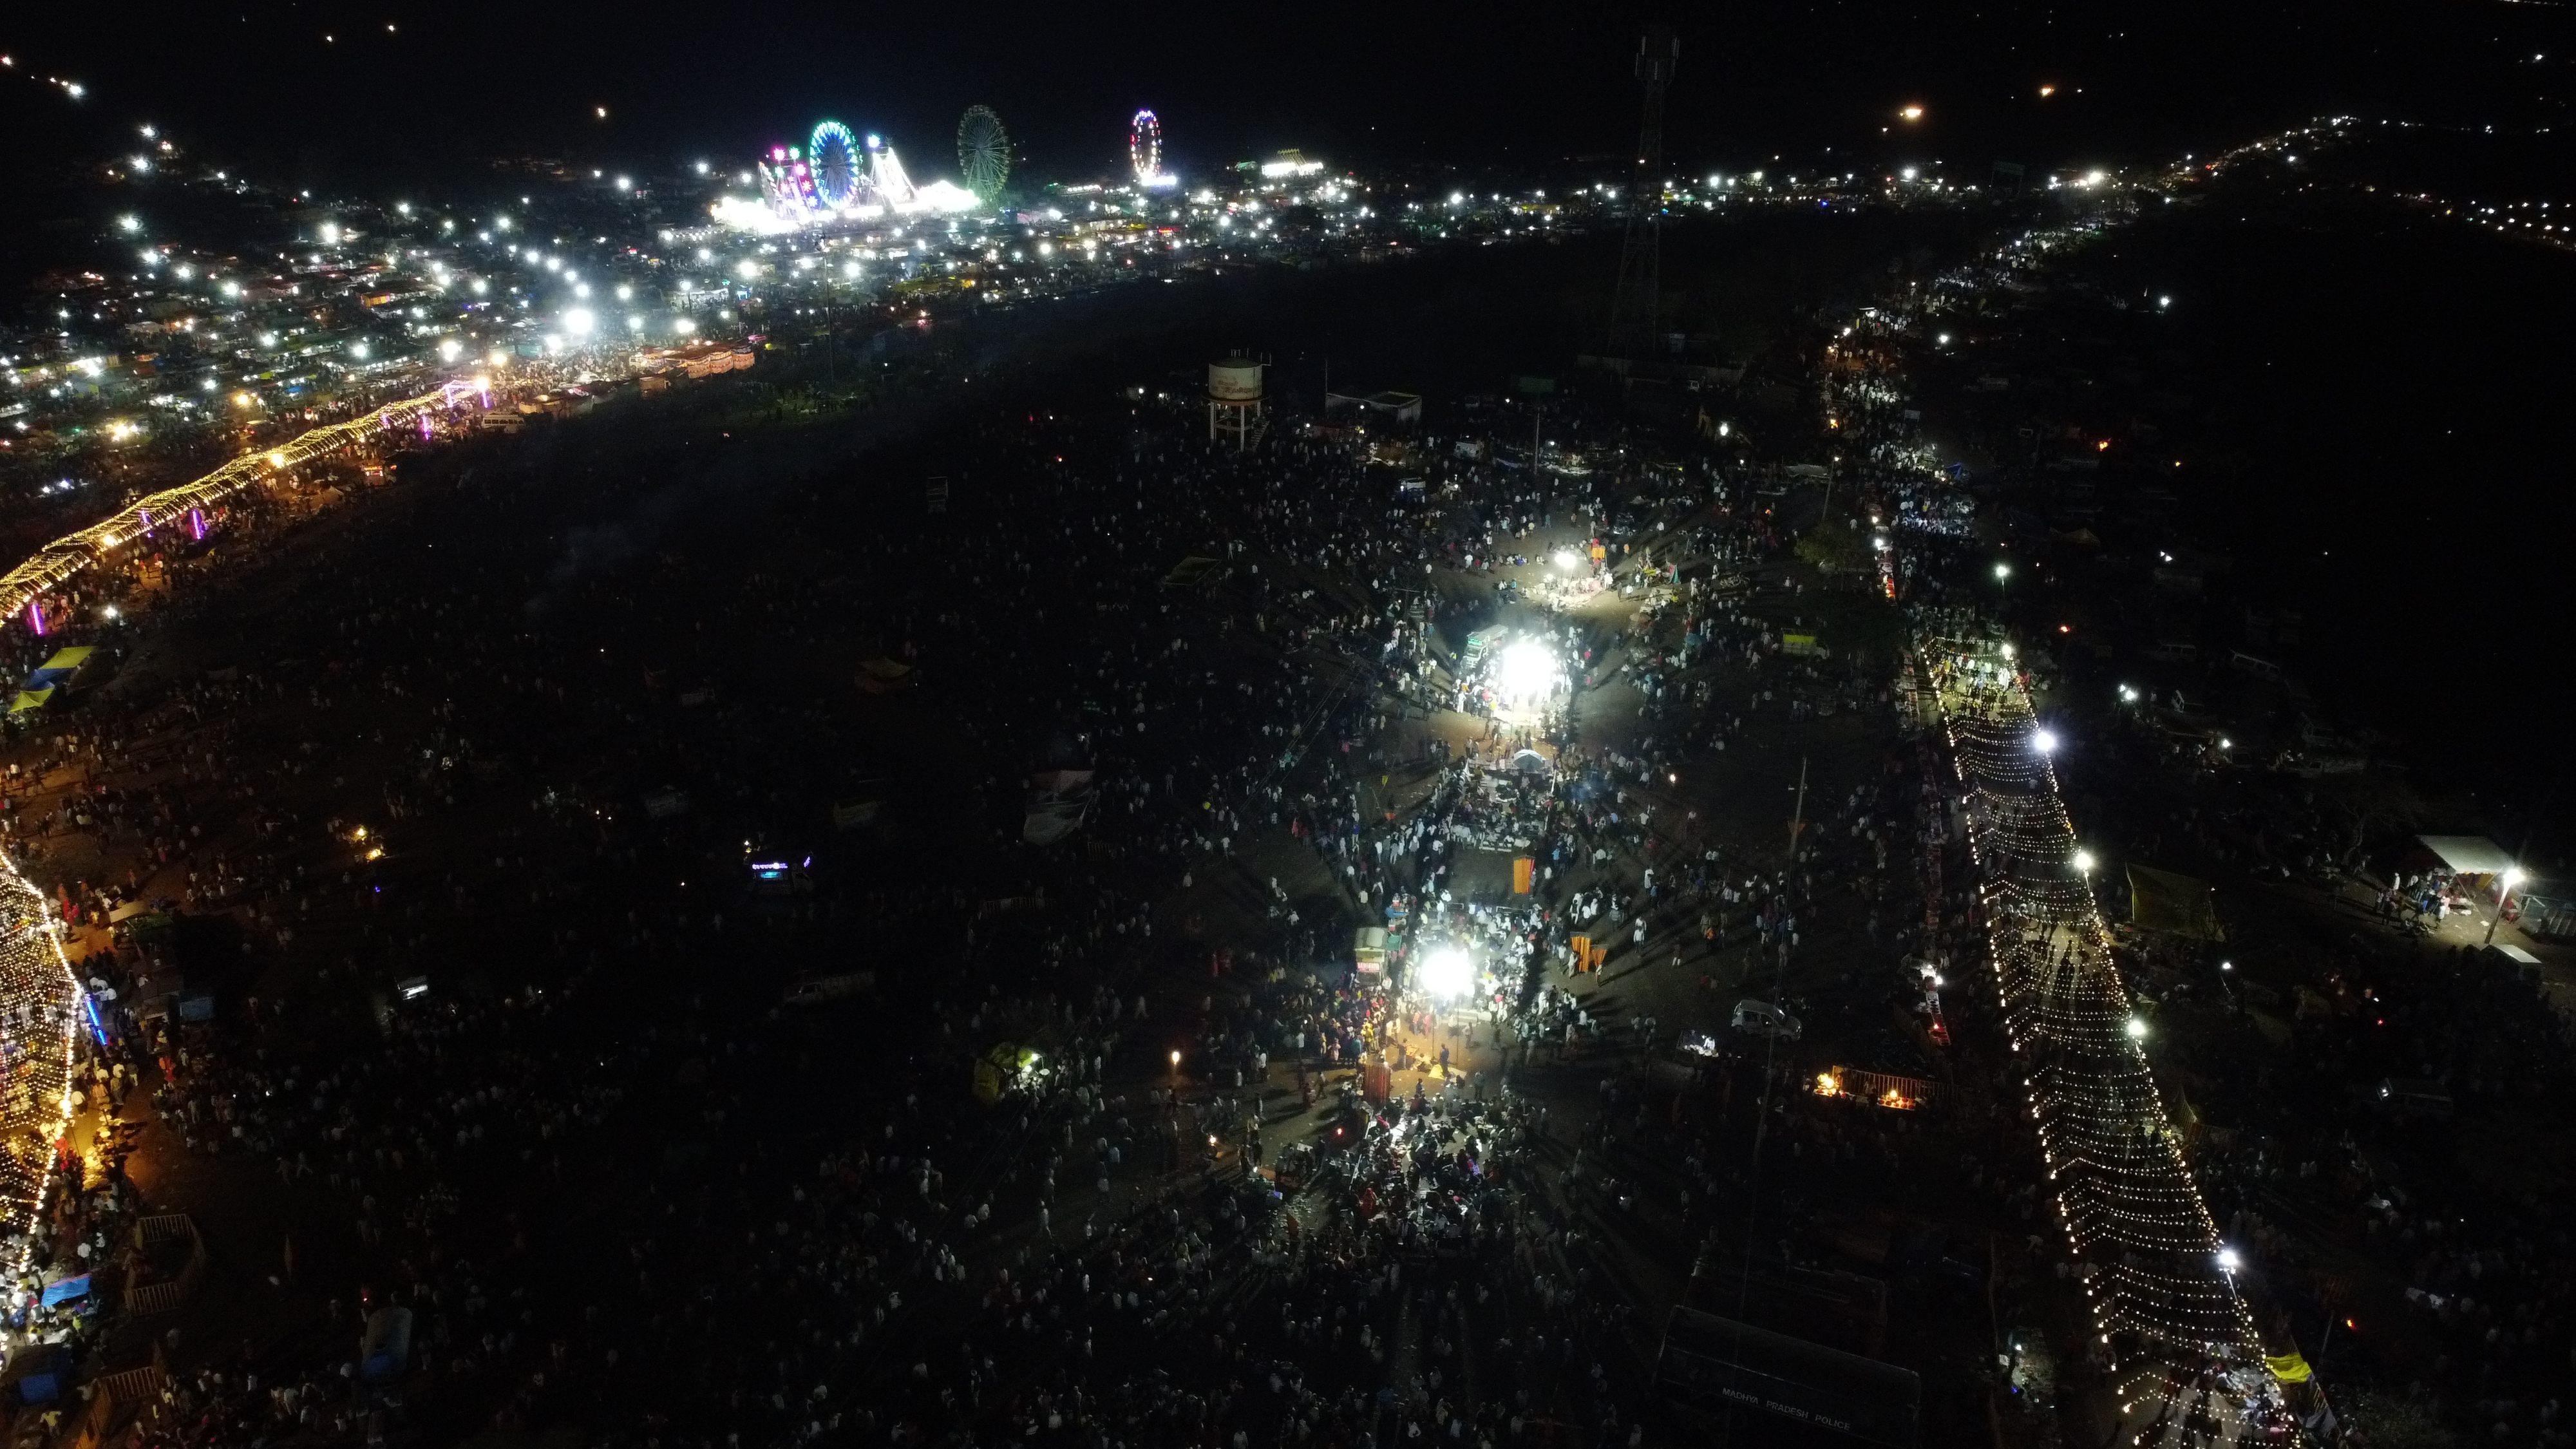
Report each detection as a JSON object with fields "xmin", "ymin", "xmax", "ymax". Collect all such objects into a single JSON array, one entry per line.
[{"xmin": 0, "ymin": 0, "xmax": 2576, "ymax": 188}]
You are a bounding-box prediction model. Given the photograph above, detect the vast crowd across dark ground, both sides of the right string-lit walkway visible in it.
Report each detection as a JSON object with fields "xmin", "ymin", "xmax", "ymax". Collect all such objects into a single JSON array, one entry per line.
[{"xmin": 0, "ymin": 192, "xmax": 2566, "ymax": 1449}]
